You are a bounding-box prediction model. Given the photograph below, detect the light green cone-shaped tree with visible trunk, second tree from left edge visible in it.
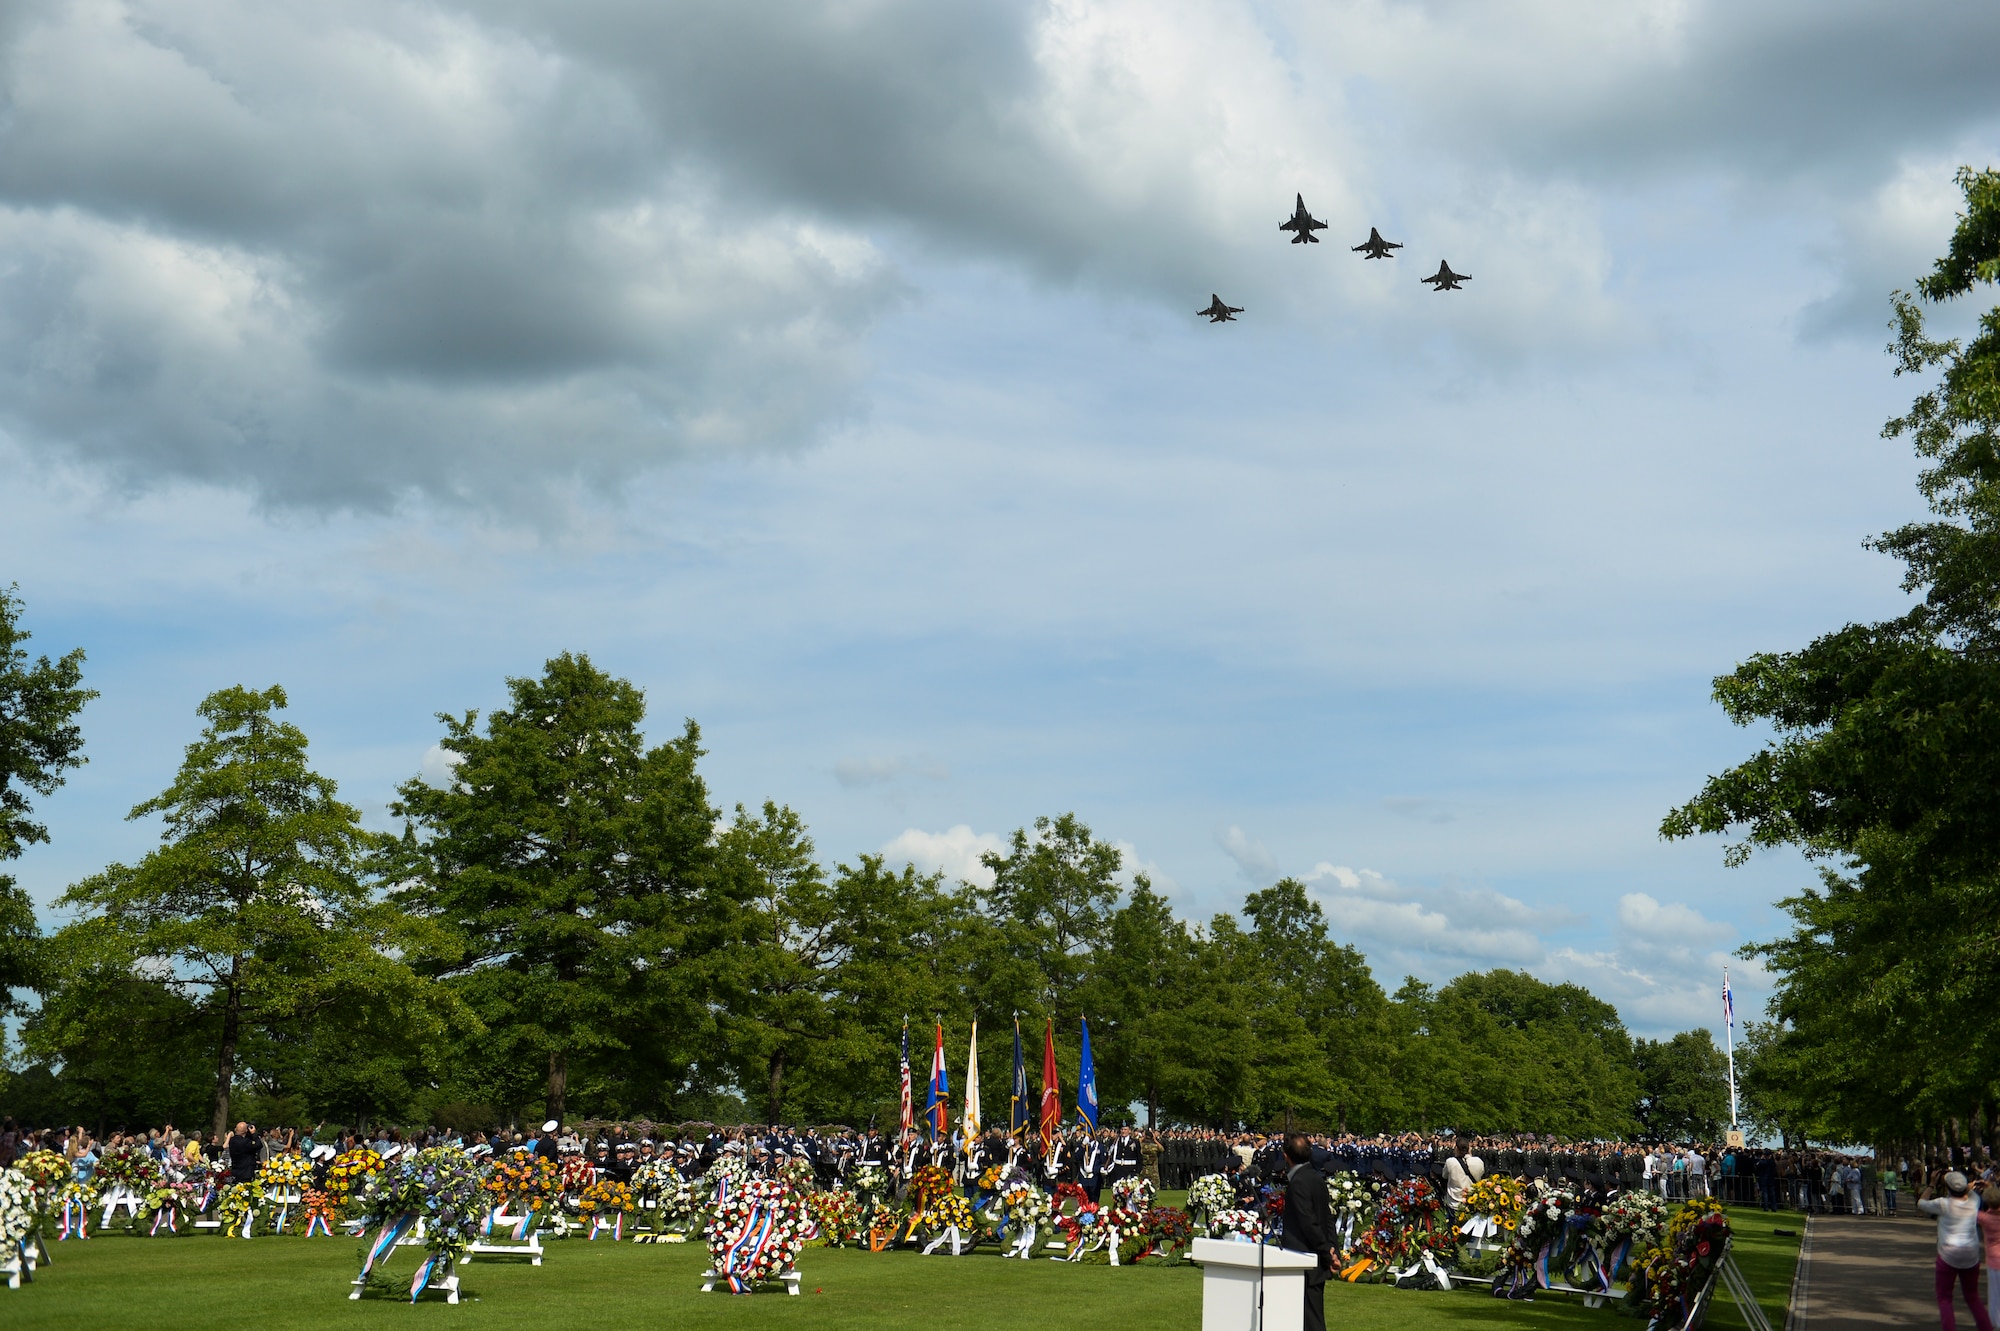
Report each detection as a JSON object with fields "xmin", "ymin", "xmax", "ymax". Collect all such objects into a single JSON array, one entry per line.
[{"xmin": 58, "ymin": 685, "xmax": 406, "ymax": 1133}]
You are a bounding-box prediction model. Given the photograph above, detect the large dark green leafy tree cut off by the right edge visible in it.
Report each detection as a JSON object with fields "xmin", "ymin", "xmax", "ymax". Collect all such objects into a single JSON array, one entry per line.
[{"xmin": 1662, "ymin": 170, "xmax": 2000, "ymax": 1139}]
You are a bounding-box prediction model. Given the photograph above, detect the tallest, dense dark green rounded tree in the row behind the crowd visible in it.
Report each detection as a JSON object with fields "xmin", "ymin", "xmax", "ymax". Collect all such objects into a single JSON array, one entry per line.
[{"xmin": 390, "ymin": 654, "xmax": 740, "ymax": 1119}]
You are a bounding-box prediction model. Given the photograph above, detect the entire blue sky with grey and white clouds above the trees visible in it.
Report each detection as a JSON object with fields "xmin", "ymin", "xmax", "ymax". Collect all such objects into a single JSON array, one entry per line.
[{"xmin": 0, "ymin": 0, "xmax": 2000, "ymax": 1033}]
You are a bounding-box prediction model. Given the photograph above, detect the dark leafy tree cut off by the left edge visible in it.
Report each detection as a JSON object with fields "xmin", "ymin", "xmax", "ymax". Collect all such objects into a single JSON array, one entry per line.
[{"xmin": 0, "ymin": 588, "xmax": 98, "ymax": 1017}]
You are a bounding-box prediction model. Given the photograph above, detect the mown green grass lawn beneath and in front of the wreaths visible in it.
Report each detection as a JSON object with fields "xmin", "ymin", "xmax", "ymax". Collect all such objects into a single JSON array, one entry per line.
[{"xmin": 0, "ymin": 1211, "xmax": 1800, "ymax": 1331}]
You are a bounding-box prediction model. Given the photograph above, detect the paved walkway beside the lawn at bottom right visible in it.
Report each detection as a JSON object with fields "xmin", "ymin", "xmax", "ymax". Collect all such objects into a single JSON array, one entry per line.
[{"xmin": 1790, "ymin": 1215, "xmax": 1960, "ymax": 1331}]
